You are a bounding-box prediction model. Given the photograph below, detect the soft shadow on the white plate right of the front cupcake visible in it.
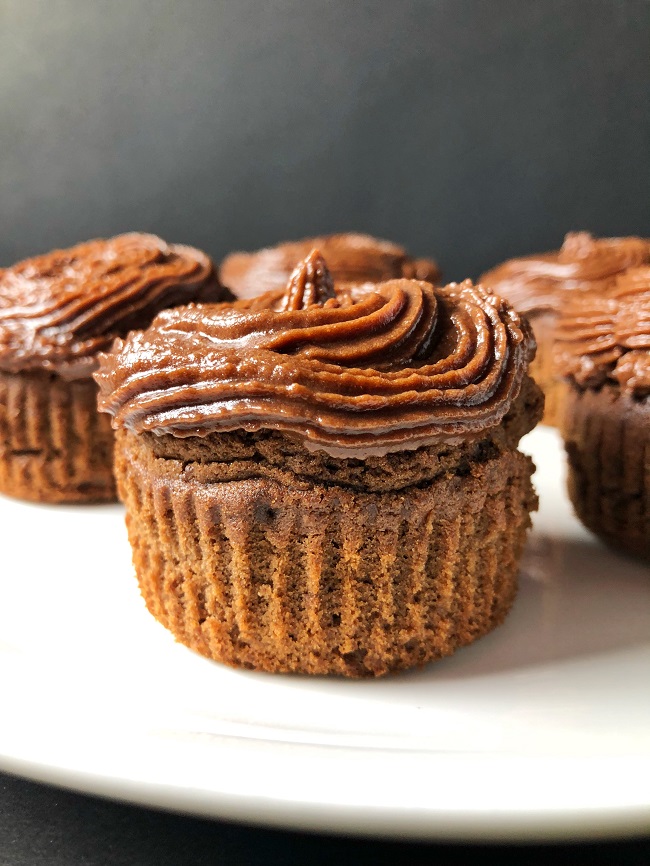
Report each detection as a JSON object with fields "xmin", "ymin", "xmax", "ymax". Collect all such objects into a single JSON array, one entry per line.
[{"xmin": 392, "ymin": 534, "xmax": 650, "ymax": 682}]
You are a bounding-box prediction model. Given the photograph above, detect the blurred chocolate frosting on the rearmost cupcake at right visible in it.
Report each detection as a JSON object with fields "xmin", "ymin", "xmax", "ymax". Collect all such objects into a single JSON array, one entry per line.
[{"xmin": 481, "ymin": 232, "xmax": 650, "ymax": 313}]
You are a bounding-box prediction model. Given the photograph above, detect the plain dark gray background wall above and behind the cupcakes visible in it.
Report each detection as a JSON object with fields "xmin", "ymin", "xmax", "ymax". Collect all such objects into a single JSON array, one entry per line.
[{"xmin": 0, "ymin": 0, "xmax": 650, "ymax": 278}]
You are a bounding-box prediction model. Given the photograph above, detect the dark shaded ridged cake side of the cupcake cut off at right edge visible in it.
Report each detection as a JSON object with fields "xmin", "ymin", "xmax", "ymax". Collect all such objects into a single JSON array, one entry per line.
[{"xmin": 562, "ymin": 386, "xmax": 650, "ymax": 558}]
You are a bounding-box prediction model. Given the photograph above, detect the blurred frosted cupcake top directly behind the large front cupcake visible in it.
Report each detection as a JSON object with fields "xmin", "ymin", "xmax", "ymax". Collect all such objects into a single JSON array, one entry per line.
[{"xmin": 219, "ymin": 233, "xmax": 440, "ymax": 298}]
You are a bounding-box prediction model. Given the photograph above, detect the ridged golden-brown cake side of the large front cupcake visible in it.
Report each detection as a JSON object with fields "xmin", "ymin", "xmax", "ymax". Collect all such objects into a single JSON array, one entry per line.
[{"xmin": 116, "ymin": 431, "xmax": 536, "ymax": 677}]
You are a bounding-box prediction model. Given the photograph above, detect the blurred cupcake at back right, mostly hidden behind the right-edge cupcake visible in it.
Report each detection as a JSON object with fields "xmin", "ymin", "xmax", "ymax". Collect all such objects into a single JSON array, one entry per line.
[{"xmin": 481, "ymin": 232, "xmax": 650, "ymax": 427}]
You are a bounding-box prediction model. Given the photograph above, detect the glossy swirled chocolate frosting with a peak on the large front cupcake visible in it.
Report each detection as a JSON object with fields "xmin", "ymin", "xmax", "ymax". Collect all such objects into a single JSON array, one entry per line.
[{"xmin": 95, "ymin": 252, "xmax": 535, "ymax": 458}]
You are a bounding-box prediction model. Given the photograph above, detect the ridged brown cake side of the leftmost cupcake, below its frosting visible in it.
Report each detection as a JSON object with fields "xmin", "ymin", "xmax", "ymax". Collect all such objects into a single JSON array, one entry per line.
[{"xmin": 0, "ymin": 371, "xmax": 116, "ymax": 502}]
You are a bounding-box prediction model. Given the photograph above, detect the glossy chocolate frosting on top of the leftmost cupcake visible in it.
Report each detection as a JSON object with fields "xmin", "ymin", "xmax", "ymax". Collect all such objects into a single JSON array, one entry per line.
[{"xmin": 0, "ymin": 233, "xmax": 227, "ymax": 379}]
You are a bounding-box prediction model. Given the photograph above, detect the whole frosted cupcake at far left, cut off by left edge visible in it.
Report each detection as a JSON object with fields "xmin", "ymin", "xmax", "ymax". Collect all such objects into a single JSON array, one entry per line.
[{"xmin": 0, "ymin": 234, "xmax": 226, "ymax": 502}]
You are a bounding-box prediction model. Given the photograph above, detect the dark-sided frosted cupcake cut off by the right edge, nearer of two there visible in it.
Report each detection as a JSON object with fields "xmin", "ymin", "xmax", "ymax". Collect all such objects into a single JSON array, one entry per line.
[{"xmin": 556, "ymin": 266, "xmax": 650, "ymax": 559}]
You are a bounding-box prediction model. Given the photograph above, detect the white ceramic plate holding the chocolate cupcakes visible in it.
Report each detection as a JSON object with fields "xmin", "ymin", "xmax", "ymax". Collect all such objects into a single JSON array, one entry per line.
[{"xmin": 0, "ymin": 428, "xmax": 650, "ymax": 840}]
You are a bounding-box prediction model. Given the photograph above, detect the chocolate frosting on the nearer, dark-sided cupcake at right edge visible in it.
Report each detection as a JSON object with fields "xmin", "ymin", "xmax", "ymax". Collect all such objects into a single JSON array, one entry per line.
[{"xmin": 556, "ymin": 266, "xmax": 650, "ymax": 397}]
